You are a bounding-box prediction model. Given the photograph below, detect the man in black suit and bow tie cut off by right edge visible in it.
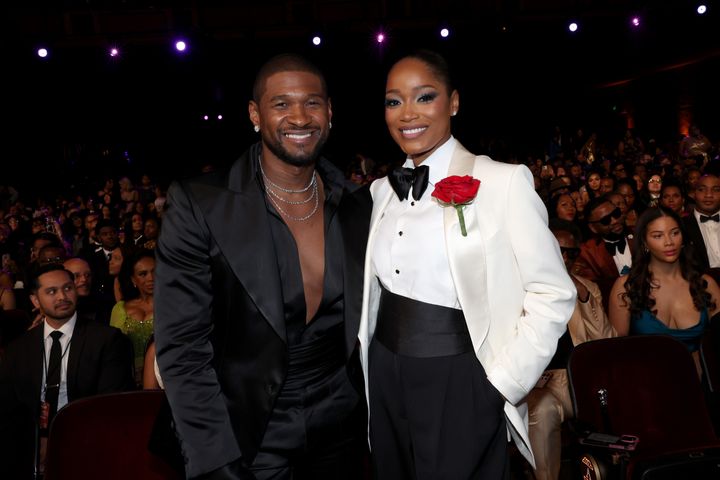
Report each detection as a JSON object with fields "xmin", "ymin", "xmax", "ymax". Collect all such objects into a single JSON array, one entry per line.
[{"xmin": 683, "ymin": 172, "xmax": 720, "ymax": 271}]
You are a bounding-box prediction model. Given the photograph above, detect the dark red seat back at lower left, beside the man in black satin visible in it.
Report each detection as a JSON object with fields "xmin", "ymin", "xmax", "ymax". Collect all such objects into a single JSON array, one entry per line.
[{"xmin": 45, "ymin": 390, "xmax": 183, "ymax": 480}]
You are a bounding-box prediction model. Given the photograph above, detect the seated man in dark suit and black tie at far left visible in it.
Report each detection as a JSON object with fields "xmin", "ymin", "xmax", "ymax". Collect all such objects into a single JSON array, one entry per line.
[{"xmin": 0, "ymin": 263, "xmax": 134, "ymax": 478}]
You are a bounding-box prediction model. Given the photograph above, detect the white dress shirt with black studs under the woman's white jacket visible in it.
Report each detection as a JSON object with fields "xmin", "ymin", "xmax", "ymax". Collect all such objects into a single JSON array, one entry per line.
[{"xmin": 372, "ymin": 137, "xmax": 460, "ymax": 309}]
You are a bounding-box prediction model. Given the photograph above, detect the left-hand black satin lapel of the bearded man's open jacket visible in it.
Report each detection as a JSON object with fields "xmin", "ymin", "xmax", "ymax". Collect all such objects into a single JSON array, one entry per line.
[{"xmin": 200, "ymin": 157, "xmax": 286, "ymax": 340}]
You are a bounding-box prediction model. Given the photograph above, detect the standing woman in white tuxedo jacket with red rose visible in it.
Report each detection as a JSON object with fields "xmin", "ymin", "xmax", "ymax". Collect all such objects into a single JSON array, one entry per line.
[{"xmin": 359, "ymin": 51, "xmax": 575, "ymax": 480}]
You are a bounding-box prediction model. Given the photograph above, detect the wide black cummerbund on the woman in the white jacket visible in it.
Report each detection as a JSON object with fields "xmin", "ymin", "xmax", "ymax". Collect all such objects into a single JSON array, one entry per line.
[{"xmin": 375, "ymin": 286, "xmax": 473, "ymax": 358}]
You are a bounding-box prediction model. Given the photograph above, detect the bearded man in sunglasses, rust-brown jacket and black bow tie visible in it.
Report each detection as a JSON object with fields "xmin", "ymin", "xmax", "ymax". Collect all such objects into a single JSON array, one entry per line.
[{"xmin": 572, "ymin": 196, "xmax": 632, "ymax": 309}]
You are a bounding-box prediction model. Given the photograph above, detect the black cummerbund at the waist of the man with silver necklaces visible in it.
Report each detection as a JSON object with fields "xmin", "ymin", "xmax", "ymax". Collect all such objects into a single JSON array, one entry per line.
[{"xmin": 284, "ymin": 323, "xmax": 345, "ymax": 391}]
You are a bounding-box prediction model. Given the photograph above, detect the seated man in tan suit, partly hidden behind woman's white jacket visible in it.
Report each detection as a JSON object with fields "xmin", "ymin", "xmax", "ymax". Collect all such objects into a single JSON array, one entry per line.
[{"xmin": 527, "ymin": 218, "xmax": 617, "ymax": 480}]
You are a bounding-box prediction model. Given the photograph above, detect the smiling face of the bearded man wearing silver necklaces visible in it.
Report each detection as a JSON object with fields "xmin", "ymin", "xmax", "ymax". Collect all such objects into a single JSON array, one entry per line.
[{"xmin": 248, "ymin": 71, "xmax": 332, "ymax": 166}]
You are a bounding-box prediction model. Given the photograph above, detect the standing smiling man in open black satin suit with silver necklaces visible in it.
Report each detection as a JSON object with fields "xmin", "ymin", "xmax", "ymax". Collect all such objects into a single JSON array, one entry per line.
[{"xmin": 155, "ymin": 55, "xmax": 371, "ymax": 479}]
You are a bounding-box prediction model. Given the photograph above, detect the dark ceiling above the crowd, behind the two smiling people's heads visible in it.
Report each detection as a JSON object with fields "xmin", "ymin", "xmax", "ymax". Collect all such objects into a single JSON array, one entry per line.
[{"xmin": 0, "ymin": 0, "xmax": 720, "ymax": 184}]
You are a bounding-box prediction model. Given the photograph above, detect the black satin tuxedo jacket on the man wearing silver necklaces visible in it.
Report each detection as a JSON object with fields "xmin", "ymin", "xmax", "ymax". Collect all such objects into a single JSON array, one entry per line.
[{"xmin": 155, "ymin": 144, "xmax": 372, "ymax": 477}]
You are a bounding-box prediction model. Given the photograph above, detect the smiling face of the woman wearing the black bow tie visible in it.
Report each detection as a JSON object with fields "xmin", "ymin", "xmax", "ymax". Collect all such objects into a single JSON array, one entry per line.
[{"xmin": 385, "ymin": 57, "xmax": 460, "ymax": 165}]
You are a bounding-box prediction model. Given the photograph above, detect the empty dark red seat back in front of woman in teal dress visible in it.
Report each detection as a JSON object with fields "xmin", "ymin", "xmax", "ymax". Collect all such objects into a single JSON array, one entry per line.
[{"xmin": 568, "ymin": 335, "xmax": 718, "ymax": 453}]
